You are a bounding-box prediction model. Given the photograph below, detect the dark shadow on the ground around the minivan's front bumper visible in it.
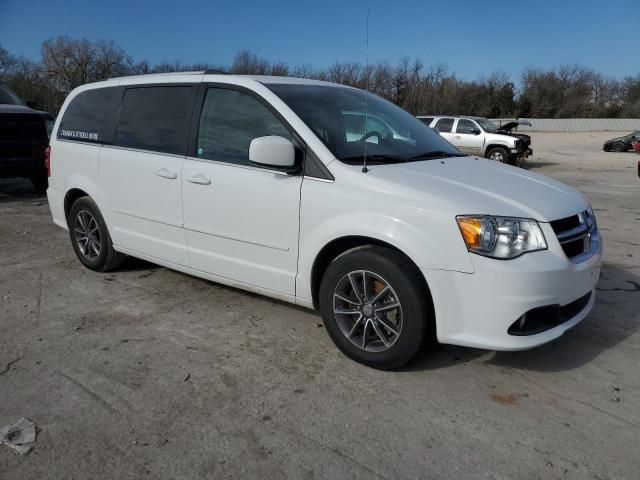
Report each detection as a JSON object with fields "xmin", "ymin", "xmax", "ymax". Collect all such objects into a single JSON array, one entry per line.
[{"xmin": 404, "ymin": 263, "xmax": 640, "ymax": 372}]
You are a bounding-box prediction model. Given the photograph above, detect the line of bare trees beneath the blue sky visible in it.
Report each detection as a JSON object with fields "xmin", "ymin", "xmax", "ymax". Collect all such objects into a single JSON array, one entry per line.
[{"xmin": 0, "ymin": 36, "xmax": 640, "ymax": 118}]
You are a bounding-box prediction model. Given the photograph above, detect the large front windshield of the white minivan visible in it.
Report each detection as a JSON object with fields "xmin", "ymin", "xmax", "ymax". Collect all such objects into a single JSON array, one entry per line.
[{"xmin": 266, "ymin": 84, "xmax": 464, "ymax": 165}]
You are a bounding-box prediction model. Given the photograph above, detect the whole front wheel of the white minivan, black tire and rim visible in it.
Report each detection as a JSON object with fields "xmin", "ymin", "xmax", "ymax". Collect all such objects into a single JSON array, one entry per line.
[{"xmin": 319, "ymin": 246, "xmax": 433, "ymax": 370}]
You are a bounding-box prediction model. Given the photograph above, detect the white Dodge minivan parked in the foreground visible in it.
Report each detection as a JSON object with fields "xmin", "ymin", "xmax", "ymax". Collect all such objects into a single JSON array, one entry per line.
[{"xmin": 47, "ymin": 72, "xmax": 602, "ymax": 369}]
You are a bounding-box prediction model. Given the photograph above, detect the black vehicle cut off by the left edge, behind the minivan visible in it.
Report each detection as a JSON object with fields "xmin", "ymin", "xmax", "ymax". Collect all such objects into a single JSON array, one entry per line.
[{"xmin": 0, "ymin": 85, "xmax": 54, "ymax": 193}]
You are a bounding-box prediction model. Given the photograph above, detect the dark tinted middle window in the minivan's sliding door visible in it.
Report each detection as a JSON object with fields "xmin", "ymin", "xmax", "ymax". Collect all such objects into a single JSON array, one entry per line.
[{"xmin": 116, "ymin": 86, "xmax": 194, "ymax": 155}]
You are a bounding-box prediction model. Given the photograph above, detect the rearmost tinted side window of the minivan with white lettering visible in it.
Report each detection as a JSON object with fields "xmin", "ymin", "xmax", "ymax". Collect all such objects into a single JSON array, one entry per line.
[{"xmin": 58, "ymin": 87, "xmax": 121, "ymax": 143}]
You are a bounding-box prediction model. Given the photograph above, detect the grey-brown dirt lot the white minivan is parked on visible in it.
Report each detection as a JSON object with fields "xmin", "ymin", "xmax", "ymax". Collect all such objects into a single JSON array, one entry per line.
[{"xmin": 0, "ymin": 133, "xmax": 640, "ymax": 480}]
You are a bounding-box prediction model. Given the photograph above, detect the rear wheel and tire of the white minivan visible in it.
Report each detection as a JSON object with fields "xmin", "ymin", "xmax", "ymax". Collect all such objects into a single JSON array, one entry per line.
[{"xmin": 67, "ymin": 197, "xmax": 126, "ymax": 272}]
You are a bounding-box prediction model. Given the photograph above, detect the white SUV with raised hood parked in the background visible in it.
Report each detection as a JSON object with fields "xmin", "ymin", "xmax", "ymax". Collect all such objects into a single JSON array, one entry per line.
[{"xmin": 418, "ymin": 115, "xmax": 533, "ymax": 167}]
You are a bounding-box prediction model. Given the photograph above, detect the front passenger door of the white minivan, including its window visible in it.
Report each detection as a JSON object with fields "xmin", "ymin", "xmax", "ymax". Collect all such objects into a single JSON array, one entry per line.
[{"xmin": 182, "ymin": 87, "xmax": 302, "ymax": 296}]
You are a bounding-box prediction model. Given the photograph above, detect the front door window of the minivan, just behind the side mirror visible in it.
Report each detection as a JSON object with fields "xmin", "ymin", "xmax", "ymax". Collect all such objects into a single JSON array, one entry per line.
[{"xmin": 196, "ymin": 88, "xmax": 292, "ymax": 165}]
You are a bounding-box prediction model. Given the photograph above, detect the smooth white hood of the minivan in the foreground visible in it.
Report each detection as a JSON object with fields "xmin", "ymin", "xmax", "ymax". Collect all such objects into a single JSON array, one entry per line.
[{"xmin": 367, "ymin": 157, "xmax": 589, "ymax": 222}]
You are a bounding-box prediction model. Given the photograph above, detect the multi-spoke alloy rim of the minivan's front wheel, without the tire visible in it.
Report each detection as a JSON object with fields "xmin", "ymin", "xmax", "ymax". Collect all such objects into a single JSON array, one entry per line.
[{"xmin": 333, "ymin": 270, "xmax": 402, "ymax": 352}]
